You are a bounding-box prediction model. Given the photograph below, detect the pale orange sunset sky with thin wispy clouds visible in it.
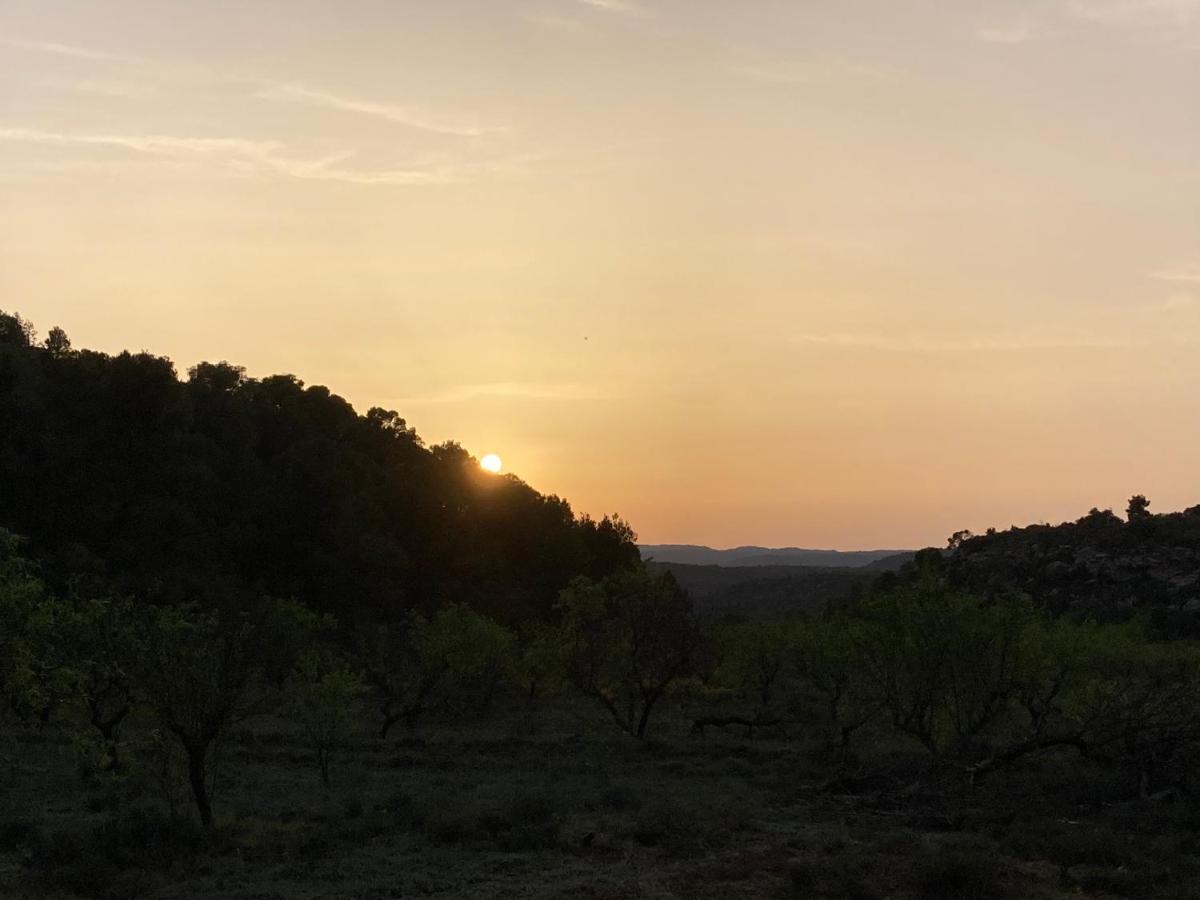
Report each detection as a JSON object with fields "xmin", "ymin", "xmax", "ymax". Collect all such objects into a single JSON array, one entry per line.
[{"xmin": 0, "ymin": 0, "xmax": 1200, "ymax": 548}]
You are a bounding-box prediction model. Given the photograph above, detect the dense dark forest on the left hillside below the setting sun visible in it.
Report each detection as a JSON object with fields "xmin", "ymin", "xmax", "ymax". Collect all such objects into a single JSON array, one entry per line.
[{"xmin": 0, "ymin": 312, "xmax": 638, "ymax": 622}]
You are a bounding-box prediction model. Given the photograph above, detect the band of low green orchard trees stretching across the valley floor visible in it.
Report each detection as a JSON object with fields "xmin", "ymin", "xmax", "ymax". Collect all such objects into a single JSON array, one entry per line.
[{"xmin": 0, "ymin": 533, "xmax": 1200, "ymax": 828}]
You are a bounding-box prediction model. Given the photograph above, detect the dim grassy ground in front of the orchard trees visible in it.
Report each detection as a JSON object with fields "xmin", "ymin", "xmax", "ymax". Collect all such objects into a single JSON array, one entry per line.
[{"xmin": 0, "ymin": 701, "xmax": 1200, "ymax": 900}]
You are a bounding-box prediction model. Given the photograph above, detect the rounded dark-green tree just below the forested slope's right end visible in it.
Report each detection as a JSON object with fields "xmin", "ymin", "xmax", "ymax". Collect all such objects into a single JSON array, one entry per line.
[{"xmin": 558, "ymin": 569, "xmax": 697, "ymax": 740}]
